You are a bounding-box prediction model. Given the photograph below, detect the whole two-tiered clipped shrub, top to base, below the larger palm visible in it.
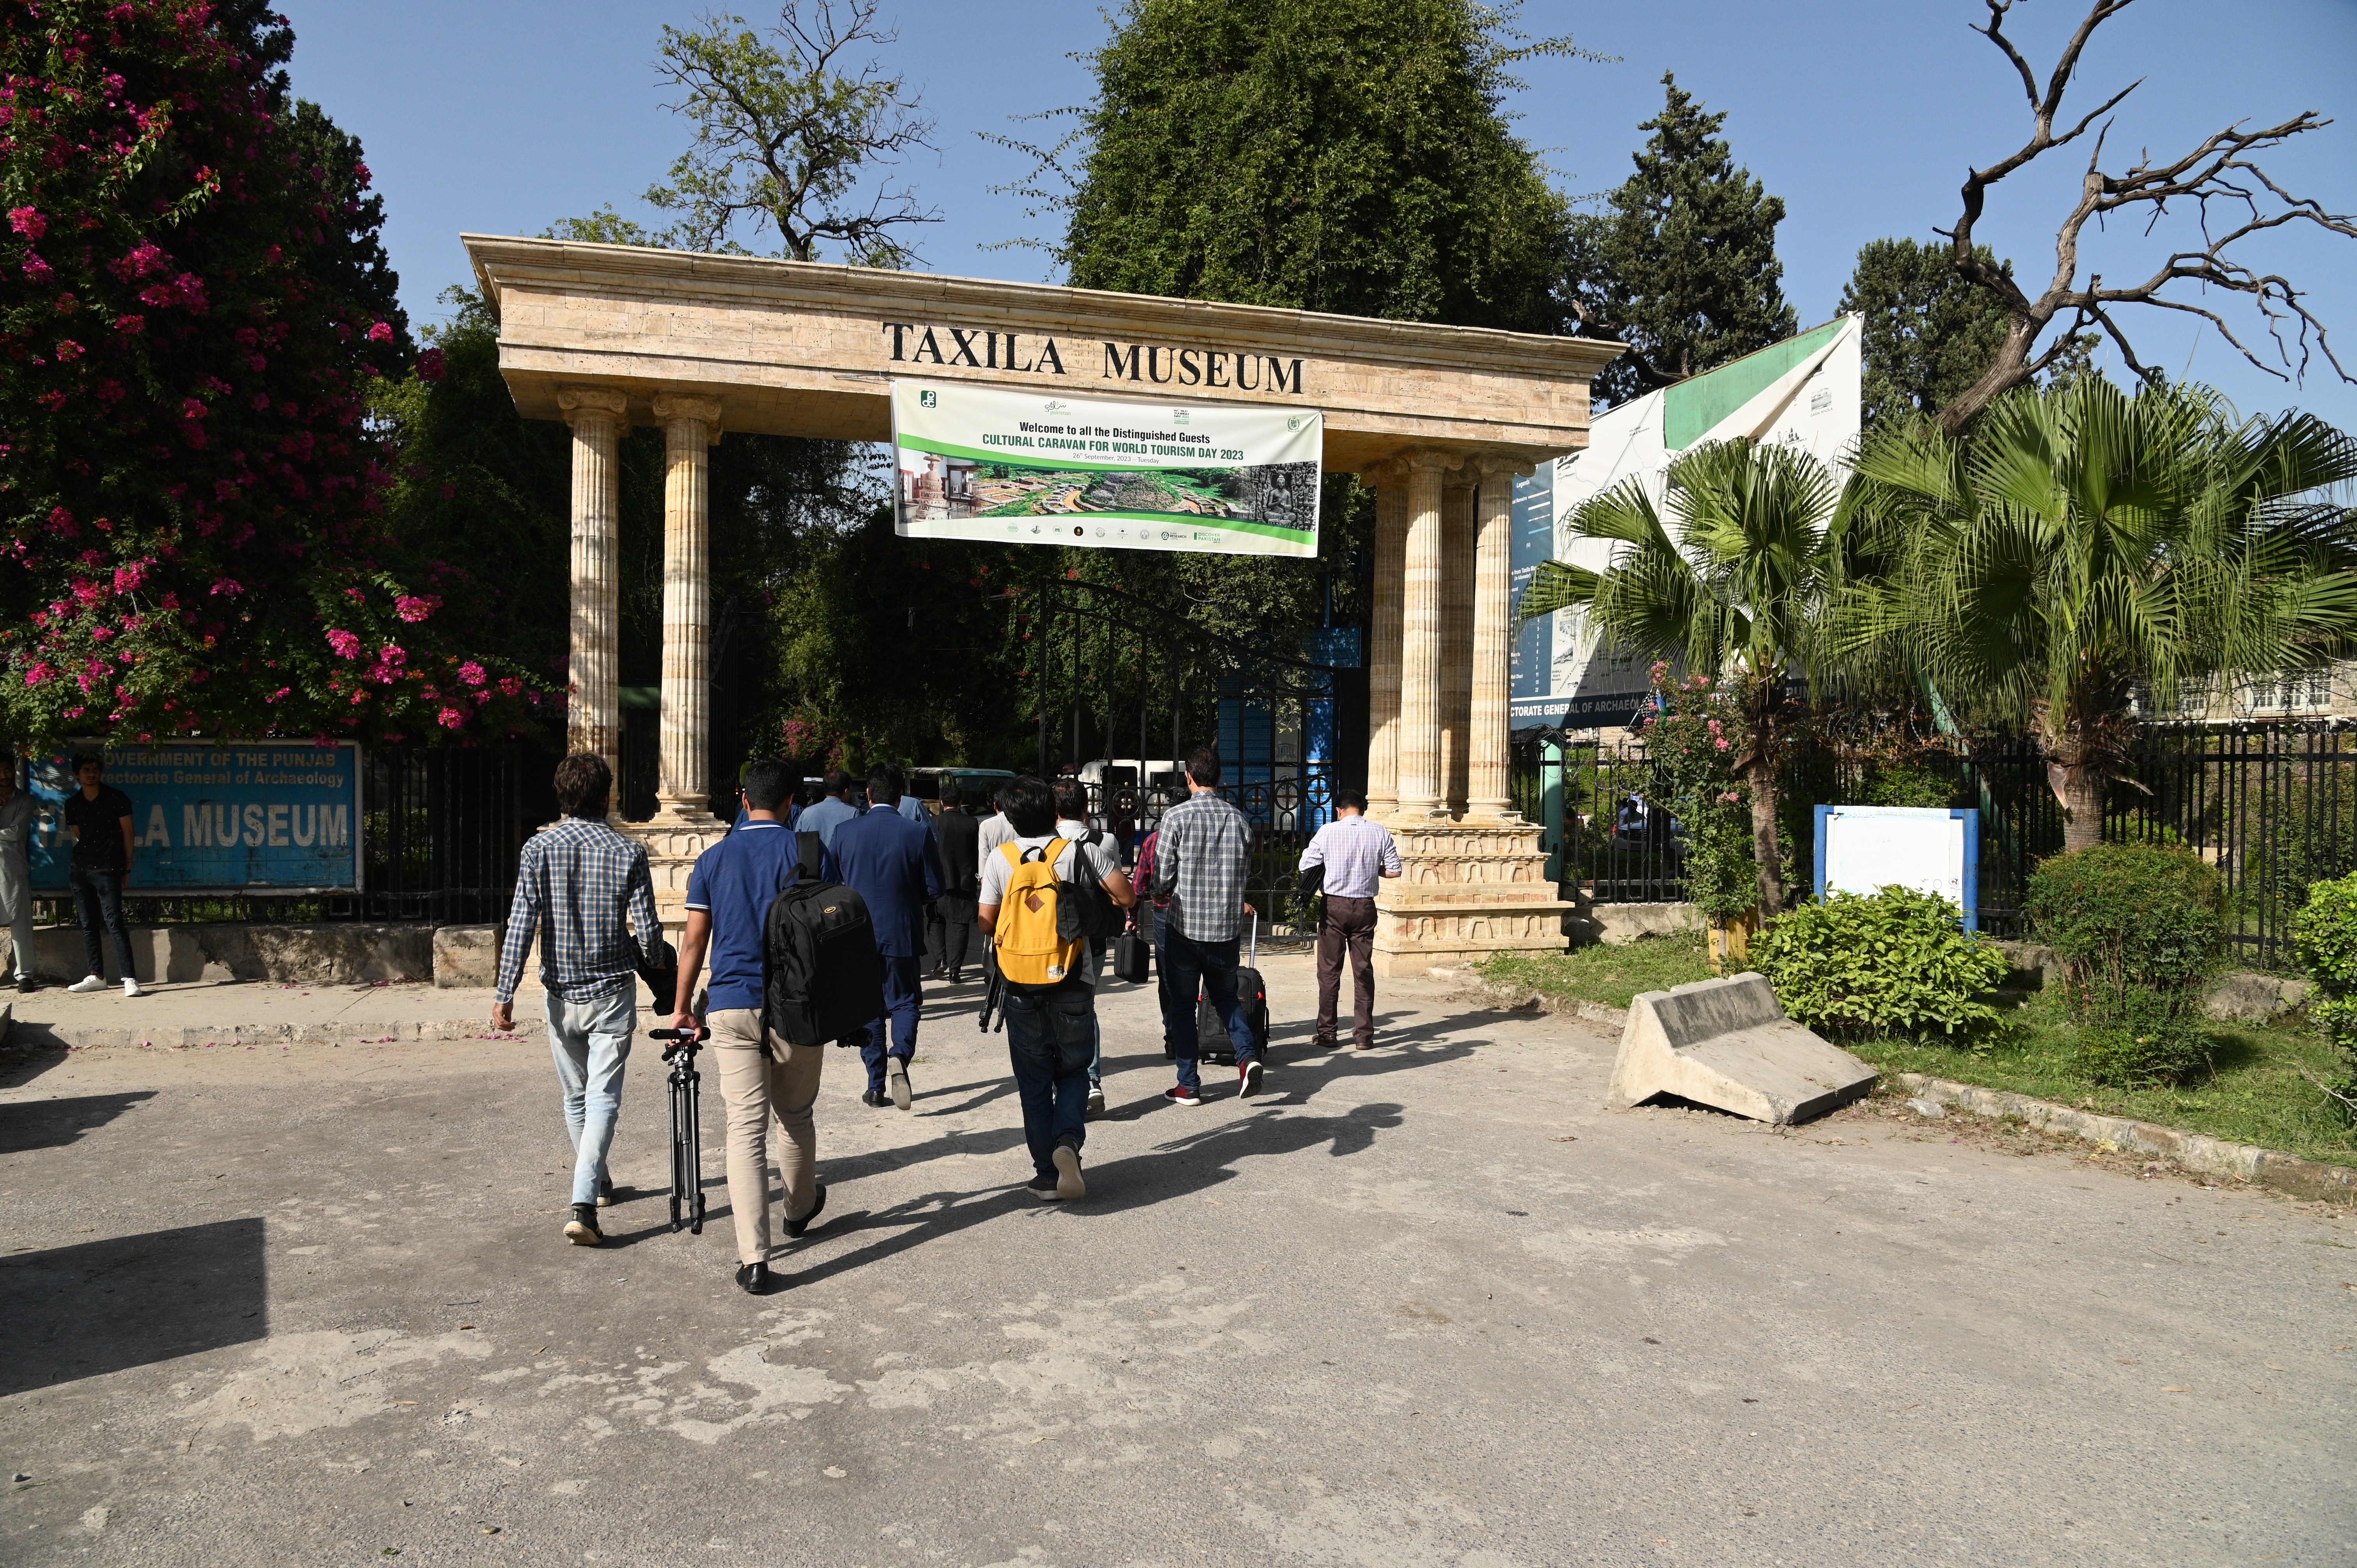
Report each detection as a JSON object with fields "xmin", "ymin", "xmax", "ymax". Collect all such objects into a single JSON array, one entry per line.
[{"xmin": 2022, "ymin": 844, "xmax": 2225, "ymax": 1087}]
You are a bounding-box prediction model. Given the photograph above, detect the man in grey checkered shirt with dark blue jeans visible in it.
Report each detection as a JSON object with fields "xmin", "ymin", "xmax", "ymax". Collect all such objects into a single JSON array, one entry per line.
[{"xmin": 1155, "ymin": 747, "xmax": 1261, "ymax": 1106}]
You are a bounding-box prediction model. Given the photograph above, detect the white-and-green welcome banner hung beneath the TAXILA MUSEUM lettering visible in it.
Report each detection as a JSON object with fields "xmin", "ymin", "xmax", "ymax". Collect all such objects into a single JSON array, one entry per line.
[{"xmin": 891, "ymin": 380, "xmax": 1325, "ymax": 556}]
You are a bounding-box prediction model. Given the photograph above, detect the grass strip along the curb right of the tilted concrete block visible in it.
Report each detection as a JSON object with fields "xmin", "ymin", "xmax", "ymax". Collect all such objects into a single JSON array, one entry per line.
[{"xmin": 1843, "ymin": 993, "xmax": 2357, "ymax": 1165}]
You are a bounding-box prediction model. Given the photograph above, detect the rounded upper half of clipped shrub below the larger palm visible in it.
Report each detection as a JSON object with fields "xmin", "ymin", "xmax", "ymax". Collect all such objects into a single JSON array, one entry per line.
[{"xmin": 2022, "ymin": 844, "xmax": 2225, "ymax": 1002}]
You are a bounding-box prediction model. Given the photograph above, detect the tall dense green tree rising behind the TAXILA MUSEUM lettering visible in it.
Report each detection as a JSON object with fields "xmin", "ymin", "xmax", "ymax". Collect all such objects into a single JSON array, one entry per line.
[{"xmin": 1053, "ymin": 0, "xmax": 1574, "ymax": 332}]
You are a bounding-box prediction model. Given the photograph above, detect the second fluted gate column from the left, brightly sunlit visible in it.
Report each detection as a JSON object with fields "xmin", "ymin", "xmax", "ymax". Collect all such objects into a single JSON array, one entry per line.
[{"xmin": 655, "ymin": 391, "xmax": 721, "ymax": 823}]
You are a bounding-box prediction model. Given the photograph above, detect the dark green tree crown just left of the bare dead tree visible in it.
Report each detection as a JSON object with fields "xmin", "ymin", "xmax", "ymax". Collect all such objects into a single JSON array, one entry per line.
[{"xmin": 1841, "ymin": 238, "xmax": 2013, "ymax": 429}]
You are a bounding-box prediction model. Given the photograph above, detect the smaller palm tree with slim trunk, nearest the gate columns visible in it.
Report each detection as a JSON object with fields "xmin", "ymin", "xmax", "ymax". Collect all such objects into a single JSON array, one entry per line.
[{"xmin": 1520, "ymin": 441, "xmax": 1843, "ymax": 915}]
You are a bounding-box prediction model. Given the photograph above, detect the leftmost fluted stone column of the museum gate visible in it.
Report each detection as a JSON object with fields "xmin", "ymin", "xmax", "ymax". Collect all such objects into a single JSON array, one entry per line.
[{"xmin": 556, "ymin": 387, "xmax": 629, "ymax": 816}]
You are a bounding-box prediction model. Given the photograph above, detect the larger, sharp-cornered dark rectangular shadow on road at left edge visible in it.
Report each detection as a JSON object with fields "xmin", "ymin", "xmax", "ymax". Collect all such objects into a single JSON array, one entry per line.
[{"xmin": 0, "ymin": 1219, "xmax": 269, "ymax": 1396}]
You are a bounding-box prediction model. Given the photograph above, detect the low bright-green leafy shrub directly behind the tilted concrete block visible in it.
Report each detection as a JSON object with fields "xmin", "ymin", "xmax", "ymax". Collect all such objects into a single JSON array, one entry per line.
[{"xmin": 1749, "ymin": 886, "xmax": 2006, "ymax": 1035}]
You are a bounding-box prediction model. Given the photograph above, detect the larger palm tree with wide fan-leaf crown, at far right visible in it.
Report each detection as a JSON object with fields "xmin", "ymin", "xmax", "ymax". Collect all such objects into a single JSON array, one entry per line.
[{"xmin": 1829, "ymin": 377, "xmax": 2357, "ymax": 849}]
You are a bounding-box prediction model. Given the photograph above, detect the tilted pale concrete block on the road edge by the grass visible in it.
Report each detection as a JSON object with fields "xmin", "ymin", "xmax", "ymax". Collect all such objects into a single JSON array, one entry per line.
[{"xmin": 1612, "ymin": 974, "xmax": 1876, "ymax": 1125}]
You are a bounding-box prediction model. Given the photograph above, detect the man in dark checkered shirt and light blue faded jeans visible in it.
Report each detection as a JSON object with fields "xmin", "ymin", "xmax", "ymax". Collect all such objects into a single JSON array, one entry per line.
[{"xmin": 490, "ymin": 752, "xmax": 665, "ymax": 1247}]
